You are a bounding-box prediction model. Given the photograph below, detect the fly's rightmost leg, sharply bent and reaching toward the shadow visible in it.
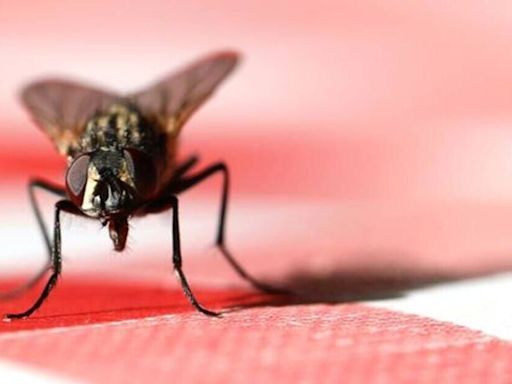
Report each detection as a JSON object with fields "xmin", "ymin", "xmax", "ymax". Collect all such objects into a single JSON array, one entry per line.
[{"xmin": 175, "ymin": 162, "xmax": 290, "ymax": 294}]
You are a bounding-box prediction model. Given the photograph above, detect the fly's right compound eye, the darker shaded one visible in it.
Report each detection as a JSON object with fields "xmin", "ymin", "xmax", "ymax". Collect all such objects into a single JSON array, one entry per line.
[{"xmin": 124, "ymin": 148, "xmax": 156, "ymax": 198}]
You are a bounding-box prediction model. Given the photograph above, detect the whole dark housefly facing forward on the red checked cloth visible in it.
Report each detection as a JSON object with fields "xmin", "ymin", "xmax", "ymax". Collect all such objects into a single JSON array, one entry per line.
[{"xmin": 6, "ymin": 52, "xmax": 279, "ymax": 319}]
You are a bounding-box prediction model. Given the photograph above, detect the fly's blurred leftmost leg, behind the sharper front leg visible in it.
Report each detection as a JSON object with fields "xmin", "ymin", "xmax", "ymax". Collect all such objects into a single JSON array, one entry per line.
[{"xmin": 0, "ymin": 179, "xmax": 66, "ymax": 299}]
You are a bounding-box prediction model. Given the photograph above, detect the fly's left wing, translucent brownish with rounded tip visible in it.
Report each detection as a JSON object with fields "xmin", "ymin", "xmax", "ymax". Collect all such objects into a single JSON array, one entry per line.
[{"xmin": 21, "ymin": 79, "xmax": 118, "ymax": 155}]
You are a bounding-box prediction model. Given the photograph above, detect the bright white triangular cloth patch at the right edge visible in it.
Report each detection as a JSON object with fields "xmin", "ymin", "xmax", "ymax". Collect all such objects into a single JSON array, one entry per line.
[{"xmin": 370, "ymin": 272, "xmax": 512, "ymax": 341}]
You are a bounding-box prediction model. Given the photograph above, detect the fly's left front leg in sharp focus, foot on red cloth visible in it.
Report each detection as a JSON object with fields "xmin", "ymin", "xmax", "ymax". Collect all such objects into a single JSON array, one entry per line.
[{"xmin": 5, "ymin": 200, "xmax": 79, "ymax": 320}]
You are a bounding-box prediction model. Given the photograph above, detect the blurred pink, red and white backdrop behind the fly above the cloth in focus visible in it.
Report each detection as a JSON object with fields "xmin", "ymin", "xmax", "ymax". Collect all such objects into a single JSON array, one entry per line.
[{"xmin": 0, "ymin": 0, "xmax": 512, "ymax": 296}]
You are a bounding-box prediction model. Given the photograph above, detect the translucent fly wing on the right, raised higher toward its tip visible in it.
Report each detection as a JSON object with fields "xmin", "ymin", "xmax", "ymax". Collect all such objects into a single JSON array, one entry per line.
[{"xmin": 129, "ymin": 52, "xmax": 238, "ymax": 137}]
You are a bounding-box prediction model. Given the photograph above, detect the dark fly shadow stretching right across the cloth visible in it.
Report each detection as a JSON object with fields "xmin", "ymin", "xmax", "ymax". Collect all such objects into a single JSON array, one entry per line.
[{"xmin": 225, "ymin": 254, "xmax": 512, "ymax": 310}]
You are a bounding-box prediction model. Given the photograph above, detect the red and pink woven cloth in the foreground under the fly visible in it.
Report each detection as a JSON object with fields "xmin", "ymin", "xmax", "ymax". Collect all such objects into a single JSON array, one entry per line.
[{"xmin": 0, "ymin": 283, "xmax": 512, "ymax": 383}]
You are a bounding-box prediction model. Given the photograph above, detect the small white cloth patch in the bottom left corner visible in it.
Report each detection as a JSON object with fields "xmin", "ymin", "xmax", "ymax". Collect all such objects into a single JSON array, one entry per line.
[{"xmin": 0, "ymin": 360, "xmax": 83, "ymax": 384}]
